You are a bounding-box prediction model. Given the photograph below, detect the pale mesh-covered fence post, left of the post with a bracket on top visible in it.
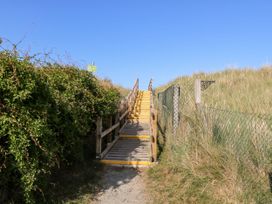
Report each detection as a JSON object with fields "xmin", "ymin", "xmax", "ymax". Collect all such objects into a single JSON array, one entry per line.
[{"xmin": 173, "ymin": 85, "xmax": 180, "ymax": 136}]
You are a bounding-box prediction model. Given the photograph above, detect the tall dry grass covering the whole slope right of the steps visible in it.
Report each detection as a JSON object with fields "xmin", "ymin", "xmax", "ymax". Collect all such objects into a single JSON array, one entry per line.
[{"xmin": 149, "ymin": 67, "xmax": 272, "ymax": 203}]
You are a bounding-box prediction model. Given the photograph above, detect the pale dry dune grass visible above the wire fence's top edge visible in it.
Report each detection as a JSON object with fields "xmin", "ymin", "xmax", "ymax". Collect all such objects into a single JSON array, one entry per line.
[{"xmin": 156, "ymin": 66, "xmax": 272, "ymax": 114}]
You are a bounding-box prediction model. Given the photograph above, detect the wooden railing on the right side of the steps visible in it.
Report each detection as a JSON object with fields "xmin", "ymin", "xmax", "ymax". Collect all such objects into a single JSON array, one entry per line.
[{"xmin": 148, "ymin": 79, "xmax": 157, "ymax": 162}]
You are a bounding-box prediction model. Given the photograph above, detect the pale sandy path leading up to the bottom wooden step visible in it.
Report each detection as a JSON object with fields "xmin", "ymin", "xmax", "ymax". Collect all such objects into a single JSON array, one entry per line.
[{"xmin": 93, "ymin": 167, "xmax": 151, "ymax": 204}]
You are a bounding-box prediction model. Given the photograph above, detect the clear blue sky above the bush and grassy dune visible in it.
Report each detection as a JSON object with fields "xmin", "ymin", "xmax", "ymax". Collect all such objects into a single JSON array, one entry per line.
[{"xmin": 0, "ymin": 0, "xmax": 272, "ymax": 89}]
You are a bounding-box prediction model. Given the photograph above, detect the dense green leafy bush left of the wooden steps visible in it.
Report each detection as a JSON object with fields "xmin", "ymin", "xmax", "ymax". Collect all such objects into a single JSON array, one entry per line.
[{"xmin": 0, "ymin": 51, "xmax": 120, "ymax": 203}]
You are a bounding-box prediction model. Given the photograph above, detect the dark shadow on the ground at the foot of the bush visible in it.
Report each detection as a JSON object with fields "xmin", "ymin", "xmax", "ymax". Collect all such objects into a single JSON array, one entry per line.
[{"xmin": 43, "ymin": 161, "xmax": 138, "ymax": 203}]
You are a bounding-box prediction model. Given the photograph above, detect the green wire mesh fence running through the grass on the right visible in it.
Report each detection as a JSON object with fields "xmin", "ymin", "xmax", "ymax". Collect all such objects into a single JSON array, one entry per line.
[{"xmin": 157, "ymin": 80, "xmax": 272, "ymax": 203}]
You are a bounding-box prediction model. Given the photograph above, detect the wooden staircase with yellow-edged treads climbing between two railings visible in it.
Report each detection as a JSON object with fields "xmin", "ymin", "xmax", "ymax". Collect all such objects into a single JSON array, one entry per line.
[{"xmin": 101, "ymin": 91, "xmax": 154, "ymax": 167}]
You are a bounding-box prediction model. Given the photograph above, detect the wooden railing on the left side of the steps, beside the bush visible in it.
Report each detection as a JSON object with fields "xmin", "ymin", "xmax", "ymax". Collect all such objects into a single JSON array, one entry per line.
[{"xmin": 96, "ymin": 79, "xmax": 139, "ymax": 159}]
